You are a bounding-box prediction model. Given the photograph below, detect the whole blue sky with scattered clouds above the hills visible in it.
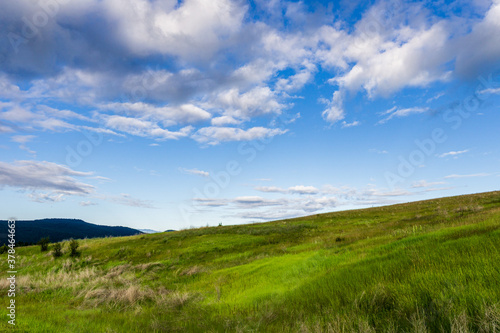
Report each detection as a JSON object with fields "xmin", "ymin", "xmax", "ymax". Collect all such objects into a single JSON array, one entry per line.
[{"xmin": 0, "ymin": 0, "xmax": 500, "ymax": 230}]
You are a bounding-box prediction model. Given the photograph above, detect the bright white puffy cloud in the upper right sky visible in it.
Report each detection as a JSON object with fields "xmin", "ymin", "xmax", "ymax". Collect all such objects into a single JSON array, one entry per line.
[{"xmin": 335, "ymin": 22, "xmax": 452, "ymax": 97}]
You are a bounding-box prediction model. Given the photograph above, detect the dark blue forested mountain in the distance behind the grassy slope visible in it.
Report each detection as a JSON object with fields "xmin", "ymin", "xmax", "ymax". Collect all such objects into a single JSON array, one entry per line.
[{"xmin": 0, "ymin": 219, "xmax": 142, "ymax": 245}]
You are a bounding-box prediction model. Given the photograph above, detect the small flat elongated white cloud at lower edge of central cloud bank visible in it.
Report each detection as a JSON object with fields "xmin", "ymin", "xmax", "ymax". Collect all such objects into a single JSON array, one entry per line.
[{"xmin": 192, "ymin": 127, "xmax": 288, "ymax": 145}]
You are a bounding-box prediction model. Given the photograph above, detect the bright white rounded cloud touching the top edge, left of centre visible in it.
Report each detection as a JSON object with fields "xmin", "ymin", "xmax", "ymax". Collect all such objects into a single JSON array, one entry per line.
[{"xmin": 102, "ymin": 0, "xmax": 246, "ymax": 59}]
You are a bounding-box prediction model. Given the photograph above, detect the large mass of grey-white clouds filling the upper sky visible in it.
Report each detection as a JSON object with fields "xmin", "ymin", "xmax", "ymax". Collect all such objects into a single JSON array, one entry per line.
[{"xmin": 0, "ymin": 0, "xmax": 500, "ymax": 139}]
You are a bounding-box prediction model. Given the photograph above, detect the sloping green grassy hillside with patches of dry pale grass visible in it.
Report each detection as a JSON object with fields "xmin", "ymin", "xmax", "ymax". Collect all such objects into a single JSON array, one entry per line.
[{"xmin": 0, "ymin": 192, "xmax": 500, "ymax": 332}]
